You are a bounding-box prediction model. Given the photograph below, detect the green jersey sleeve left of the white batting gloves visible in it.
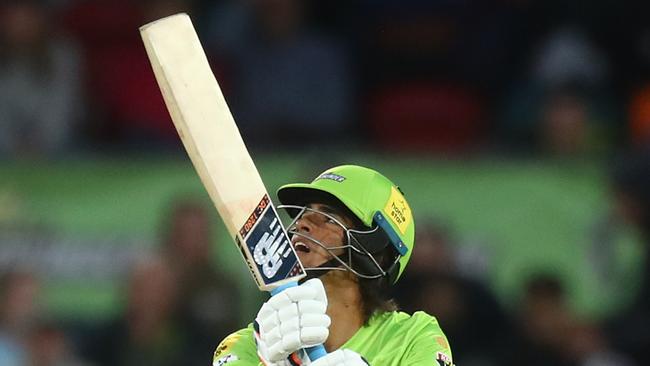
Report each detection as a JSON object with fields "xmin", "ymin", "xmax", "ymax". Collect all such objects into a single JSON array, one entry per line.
[{"xmin": 212, "ymin": 327, "xmax": 261, "ymax": 366}]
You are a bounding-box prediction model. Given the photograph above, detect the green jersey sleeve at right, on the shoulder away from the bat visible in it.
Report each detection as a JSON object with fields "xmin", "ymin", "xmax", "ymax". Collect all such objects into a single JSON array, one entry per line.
[{"xmin": 405, "ymin": 312, "xmax": 454, "ymax": 366}]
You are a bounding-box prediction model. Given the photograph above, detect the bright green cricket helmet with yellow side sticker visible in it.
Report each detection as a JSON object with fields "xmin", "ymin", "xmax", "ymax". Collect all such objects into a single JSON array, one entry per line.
[{"xmin": 278, "ymin": 165, "xmax": 415, "ymax": 284}]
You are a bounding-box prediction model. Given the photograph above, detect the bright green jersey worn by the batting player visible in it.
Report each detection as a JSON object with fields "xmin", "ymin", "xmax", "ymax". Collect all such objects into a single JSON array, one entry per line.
[{"xmin": 214, "ymin": 311, "xmax": 452, "ymax": 366}]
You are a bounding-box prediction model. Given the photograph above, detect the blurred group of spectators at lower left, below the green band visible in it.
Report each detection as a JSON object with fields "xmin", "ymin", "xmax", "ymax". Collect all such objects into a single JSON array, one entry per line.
[{"xmin": 0, "ymin": 198, "xmax": 241, "ymax": 366}]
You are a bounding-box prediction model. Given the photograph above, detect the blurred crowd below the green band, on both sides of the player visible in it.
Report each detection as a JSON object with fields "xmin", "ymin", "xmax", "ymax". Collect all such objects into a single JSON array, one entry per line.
[{"xmin": 5, "ymin": 156, "xmax": 650, "ymax": 366}]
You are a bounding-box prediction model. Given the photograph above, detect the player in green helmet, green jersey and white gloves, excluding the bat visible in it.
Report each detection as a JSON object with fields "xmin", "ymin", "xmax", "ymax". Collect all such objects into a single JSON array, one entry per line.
[{"xmin": 213, "ymin": 165, "xmax": 453, "ymax": 366}]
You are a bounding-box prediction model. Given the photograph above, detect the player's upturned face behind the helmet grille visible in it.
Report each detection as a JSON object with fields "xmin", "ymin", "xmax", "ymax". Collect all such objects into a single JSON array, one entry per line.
[{"xmin": 291, "ymin": 204, "xmax": 351, "ymax": 268}]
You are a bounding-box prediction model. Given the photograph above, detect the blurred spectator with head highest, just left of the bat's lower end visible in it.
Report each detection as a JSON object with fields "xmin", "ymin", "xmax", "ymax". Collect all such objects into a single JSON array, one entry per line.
[{"xmin": 164, "ymin": 199, "xmax": 241, "ymax": 365}]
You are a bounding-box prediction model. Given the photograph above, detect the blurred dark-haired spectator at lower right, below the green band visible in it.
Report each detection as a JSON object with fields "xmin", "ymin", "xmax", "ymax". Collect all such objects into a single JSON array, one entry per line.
[{"xmin": 505, "ymin": 274, "xmax": 633, "ymax": 366}]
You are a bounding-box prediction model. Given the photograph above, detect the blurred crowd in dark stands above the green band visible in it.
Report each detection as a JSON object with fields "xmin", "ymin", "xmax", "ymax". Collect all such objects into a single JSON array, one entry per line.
[{"xmin": 0, "ymin": 0, "xmax": 650, "ymax": 159}]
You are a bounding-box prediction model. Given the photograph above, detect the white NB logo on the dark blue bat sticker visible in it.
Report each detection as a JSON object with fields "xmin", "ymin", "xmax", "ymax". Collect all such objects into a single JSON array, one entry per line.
[{"xmin": 253, "ymin": 217, "xmax": 291, "ymax": 278}]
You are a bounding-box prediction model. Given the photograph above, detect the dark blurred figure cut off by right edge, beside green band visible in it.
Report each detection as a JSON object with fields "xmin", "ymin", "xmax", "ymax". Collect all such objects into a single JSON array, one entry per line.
[{"xmin": 608, "ymin": 147, "xmax": 650, "ymax": 365}]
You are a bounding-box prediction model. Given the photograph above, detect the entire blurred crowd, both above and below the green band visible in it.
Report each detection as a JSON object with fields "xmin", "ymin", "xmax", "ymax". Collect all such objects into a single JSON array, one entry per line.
[{"xmin": 0, "ymin": 0, "xmax": 650, "ymax": 366}]
